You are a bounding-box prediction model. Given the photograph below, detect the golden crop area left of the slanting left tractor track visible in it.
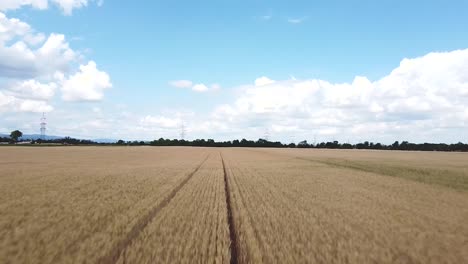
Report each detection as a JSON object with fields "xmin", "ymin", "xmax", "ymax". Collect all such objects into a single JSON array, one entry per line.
[{"xmin": 0, "ymin": 149, "xmax": 210, "ymax": 263}]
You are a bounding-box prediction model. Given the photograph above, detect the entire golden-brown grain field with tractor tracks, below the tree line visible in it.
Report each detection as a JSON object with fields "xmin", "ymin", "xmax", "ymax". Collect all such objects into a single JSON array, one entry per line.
[{"xmin": 0, "ymin": 147, "xmax": 468, "ymax": 263}]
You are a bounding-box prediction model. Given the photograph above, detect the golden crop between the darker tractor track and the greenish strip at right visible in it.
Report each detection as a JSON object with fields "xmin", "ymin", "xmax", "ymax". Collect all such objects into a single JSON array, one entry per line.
[{"xmin": 224, "ymin": 150, "xmax": 468, "ymax": 263}]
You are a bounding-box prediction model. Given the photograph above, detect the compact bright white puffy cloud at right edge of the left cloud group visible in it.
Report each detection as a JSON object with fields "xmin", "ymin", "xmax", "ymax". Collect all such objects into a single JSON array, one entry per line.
[{"xmin": 61, "ymin": 61, "xmax": 112, "ymax": 101}]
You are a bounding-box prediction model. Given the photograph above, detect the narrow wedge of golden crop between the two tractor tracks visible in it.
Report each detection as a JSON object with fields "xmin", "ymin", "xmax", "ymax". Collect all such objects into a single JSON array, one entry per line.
[{"xmin": 113, "ymin": 154, "xmax": 230, "ymax": 263}]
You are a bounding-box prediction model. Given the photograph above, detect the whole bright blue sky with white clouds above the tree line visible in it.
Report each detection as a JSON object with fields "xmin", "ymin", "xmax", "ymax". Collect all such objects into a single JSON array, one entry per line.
[{"xmin": 0, "ymin": 0, "xmax": 468, "ymax": 142}]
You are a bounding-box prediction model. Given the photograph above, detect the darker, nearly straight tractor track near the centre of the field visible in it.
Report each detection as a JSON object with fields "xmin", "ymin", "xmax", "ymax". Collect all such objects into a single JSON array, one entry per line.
[{"xmin": 219, "ymin": 152, "xmax": 240, "ymax": 264}]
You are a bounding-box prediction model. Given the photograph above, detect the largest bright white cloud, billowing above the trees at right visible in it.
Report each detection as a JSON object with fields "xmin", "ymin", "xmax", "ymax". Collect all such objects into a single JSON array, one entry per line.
[{"xmin": 212, "ymin": 49, "xmax": 468, "ymax": 143}]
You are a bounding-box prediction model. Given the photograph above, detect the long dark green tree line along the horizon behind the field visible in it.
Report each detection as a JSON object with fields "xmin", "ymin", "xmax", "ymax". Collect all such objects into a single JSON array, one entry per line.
[{"xmin": 0, "ymin": 130, "xmax": 468, "ymax": 152}]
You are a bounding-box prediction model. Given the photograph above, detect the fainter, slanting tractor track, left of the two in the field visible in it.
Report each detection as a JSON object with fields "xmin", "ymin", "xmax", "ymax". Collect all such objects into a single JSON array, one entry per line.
[{"xmin": 97, "ymin": 154, "xmax": 210, "ymax": 264}]
